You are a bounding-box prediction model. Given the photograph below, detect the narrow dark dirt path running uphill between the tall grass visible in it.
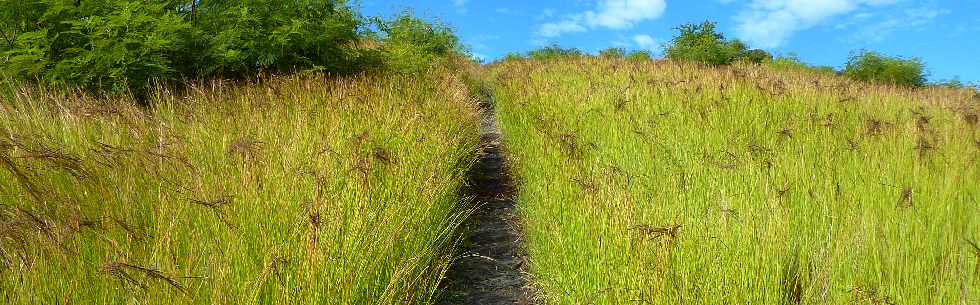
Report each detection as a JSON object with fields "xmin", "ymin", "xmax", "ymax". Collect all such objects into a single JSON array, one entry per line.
[{"xmin": 439, "ymin": 99, "xmax": 533, "ymax": 305}]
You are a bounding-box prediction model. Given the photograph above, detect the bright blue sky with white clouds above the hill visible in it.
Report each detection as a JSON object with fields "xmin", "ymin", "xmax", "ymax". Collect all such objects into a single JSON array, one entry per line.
[{"xmin": 353, "ymin": 0, "xmax": 980, "ymax": 83}]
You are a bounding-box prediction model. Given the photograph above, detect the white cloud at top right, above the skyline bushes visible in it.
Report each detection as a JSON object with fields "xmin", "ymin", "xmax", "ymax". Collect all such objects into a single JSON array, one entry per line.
[{"xmin": 735, "ymin": 0, "xmax": 898, "ymax": 48}]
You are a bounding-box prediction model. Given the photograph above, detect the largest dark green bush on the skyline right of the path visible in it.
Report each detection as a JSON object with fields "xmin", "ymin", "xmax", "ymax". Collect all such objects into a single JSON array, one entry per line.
[{"xmin": 665, "ymin": 21, "xmax": 772, "ymax": 66}]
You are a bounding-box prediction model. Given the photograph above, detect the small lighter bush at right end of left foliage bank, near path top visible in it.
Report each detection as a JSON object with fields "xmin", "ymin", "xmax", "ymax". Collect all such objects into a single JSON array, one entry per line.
[{"xmin": 378, "ymin": 11, "xmax": 465, "ymax": 73}]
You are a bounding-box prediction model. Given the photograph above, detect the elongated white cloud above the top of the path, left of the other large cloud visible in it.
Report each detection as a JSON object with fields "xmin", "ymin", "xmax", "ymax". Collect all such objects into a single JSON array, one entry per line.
[{"xmin": 538, "ymin": 0, "xmax": 667, "ymax": 37}]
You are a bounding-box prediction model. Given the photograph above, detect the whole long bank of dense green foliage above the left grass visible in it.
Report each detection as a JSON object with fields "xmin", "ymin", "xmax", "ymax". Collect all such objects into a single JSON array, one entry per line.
[{"xmin": 0, "ymin": 0, "xmax": 462, "ymax": 97}]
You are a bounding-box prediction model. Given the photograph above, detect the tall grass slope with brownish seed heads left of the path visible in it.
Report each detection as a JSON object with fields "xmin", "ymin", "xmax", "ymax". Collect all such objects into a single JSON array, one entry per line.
[{"xmin": 0, "ymin": 72, "xmax": 478, "ymax": 304}]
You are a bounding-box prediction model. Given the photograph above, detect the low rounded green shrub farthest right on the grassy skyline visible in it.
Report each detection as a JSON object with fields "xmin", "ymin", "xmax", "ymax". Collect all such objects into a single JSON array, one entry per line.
[{"xmin": 844, "ymin": 51, "xmax": 926, "ymax": 87}]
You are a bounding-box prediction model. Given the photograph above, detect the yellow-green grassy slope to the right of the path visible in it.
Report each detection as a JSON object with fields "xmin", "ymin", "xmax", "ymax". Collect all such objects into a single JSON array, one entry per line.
[{"xmin": 494, "ymin": 59, "xmax": 980, "ymax": 304}]
